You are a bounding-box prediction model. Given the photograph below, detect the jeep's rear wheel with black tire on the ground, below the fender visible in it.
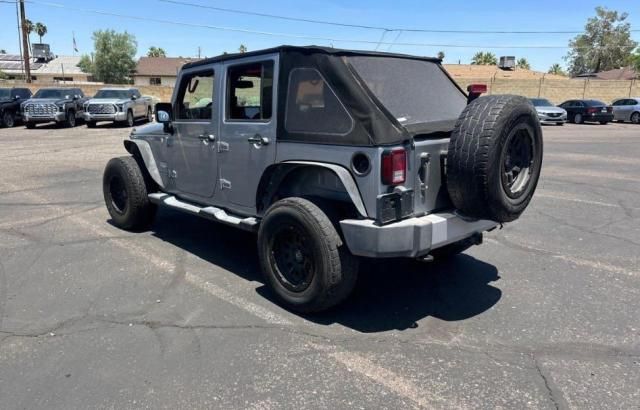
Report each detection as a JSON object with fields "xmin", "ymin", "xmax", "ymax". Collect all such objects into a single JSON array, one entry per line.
[{"xmin": 258, "ymin": 197, "xmax": 358, "ymax": 313}]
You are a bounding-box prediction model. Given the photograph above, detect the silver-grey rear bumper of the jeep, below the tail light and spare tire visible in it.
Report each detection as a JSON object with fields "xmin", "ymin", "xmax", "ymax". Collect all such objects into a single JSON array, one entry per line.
[{"xmin": 340, "ymin": 212, "xmax": 498, "ymax": 258}]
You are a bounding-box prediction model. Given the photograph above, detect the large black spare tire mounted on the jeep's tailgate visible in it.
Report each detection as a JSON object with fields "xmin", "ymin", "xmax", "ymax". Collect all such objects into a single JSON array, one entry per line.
[{"xmin": 447, "ymin": 95, "xmax": 542, "ymax": 222}]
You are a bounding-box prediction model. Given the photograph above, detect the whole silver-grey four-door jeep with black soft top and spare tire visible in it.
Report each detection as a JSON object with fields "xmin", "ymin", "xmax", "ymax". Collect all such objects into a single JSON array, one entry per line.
[{"xmin": 103, "ymin": 46, "xmax": 542, "ymax": 312}]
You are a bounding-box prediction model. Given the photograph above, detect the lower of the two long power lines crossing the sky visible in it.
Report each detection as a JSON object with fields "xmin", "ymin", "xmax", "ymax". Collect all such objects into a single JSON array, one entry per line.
[{"xmin": 13, "ymin": 0, "xmax": 640, "ymax": 49}]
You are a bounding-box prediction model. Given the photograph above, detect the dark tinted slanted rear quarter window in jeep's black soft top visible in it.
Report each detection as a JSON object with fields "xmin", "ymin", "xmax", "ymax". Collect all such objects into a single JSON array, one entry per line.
[{"xmin": 285, "ymin": 68, "xmax": 353, "ymax": 135}]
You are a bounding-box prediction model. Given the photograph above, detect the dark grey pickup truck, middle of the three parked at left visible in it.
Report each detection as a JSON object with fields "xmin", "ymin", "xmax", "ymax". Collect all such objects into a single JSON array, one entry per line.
[{"xmin": 22, "ymin": 88, "xmax": 87, "ymax": 128}]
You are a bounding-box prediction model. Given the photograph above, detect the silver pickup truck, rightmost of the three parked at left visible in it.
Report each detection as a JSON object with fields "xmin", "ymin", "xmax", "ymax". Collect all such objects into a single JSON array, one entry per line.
[{"xmin": 84, "ymin": 88, "xmax": 153, "ymax": 128}]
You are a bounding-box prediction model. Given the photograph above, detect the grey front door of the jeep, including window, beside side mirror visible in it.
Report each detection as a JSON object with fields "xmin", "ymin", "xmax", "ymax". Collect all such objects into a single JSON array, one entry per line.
[{"xmin": 167, "ymin": 64, "xmax": 218, "ymax": 202}]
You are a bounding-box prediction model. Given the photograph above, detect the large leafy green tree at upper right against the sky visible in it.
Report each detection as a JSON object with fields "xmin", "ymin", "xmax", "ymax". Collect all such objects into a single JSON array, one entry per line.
[{"xmin": 565, "ymin": 7, "xmax": 638, "ymax": 75}]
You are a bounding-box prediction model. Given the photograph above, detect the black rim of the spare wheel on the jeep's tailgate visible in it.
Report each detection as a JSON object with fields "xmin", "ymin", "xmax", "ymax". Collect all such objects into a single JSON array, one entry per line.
[{"xmin": 501, "ymin": 124, "xmax": 536, "ymax": 198}]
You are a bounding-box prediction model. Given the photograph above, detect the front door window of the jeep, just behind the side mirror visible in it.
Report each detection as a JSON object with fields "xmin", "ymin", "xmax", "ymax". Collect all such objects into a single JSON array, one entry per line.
[{"xmin": 175, "ymin": 70, "xmax": 215, "ymax": 120}]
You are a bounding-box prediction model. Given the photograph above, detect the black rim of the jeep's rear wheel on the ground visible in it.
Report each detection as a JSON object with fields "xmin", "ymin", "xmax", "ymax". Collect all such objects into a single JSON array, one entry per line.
[{"xmin": 270, "ymin": 224, "xmax": 316, "ymax": 293}]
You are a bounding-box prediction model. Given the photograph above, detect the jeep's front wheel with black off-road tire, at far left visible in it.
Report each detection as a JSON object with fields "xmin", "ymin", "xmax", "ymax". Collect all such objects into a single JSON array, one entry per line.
[{"xmin": 102, "ymin": 156, "xmax": 156, "ymax": 231}]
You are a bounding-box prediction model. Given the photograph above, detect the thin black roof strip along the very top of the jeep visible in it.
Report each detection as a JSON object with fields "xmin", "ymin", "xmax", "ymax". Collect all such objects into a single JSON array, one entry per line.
[{"xmin": 183, "ymin": 45, "xmax": 442, "ymax": 68}]
